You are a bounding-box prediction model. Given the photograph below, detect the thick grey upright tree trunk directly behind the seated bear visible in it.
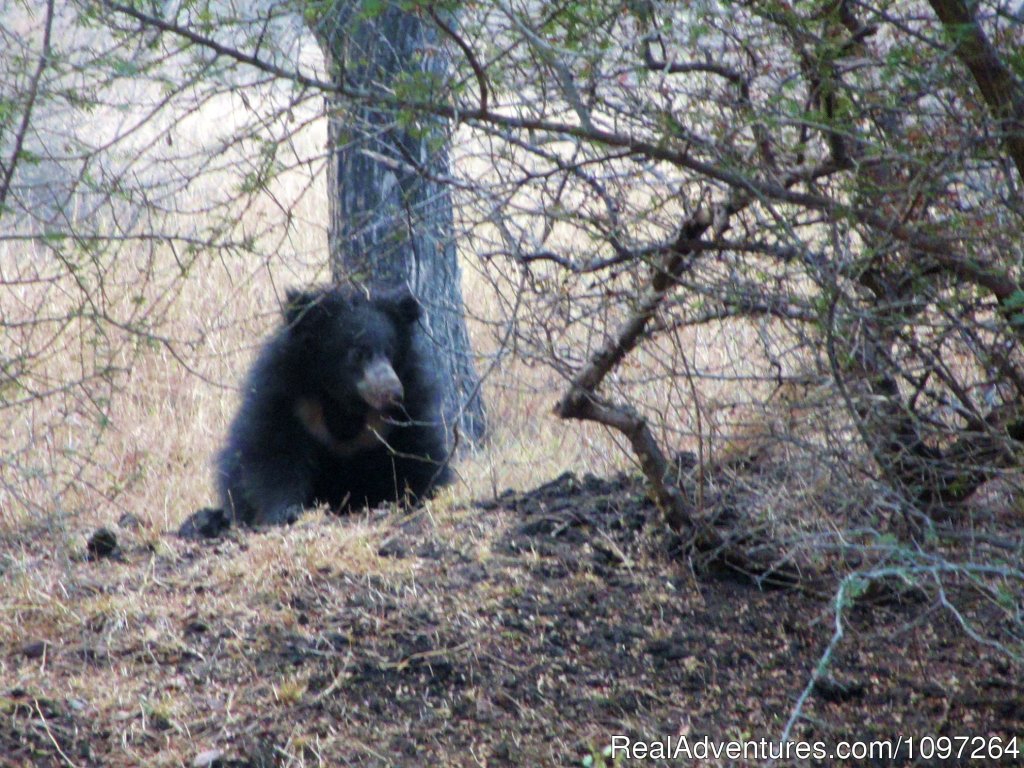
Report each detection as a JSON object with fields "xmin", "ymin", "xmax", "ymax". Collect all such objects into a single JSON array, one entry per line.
[{"xmin": 315, "ymin": 0, "xmax": 484, "ymax": 442}]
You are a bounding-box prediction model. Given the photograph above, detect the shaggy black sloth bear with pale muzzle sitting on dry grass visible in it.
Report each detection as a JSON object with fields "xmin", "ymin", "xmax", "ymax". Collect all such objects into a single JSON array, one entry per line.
[{"xmin": 218, "ymin": 288, "xmax": 450, "ymax": 525}]
